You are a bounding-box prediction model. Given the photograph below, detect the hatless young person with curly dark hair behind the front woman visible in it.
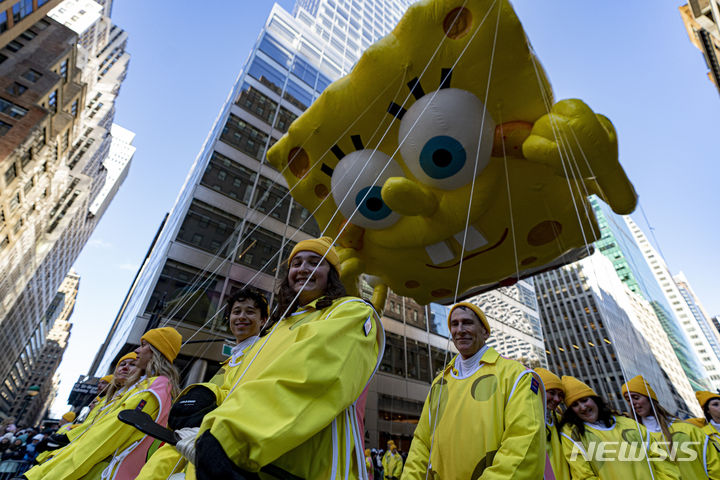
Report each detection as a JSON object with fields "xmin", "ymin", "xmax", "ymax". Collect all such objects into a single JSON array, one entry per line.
[{"xmin": 137, "ymin": 286, "xmax": 268, "ymax": 480}]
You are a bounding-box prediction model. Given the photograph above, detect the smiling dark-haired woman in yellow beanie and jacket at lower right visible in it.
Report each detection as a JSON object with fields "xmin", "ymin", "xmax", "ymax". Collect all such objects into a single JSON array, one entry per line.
[{"xmin": 560, "ymin": 376, "xmax": 680, "ymax": 480}]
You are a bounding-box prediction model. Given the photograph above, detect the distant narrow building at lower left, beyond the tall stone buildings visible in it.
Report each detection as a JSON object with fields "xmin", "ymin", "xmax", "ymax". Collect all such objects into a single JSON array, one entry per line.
[{"xmin": 9, "ymin": 271, "xmax": 80, "ymax": 425}]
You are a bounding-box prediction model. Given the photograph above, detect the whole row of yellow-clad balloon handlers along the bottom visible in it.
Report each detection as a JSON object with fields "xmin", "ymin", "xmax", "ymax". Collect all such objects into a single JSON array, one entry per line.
[{"xmin": 3, "ymin": 237, "xmax": 720, "ymax": 480}]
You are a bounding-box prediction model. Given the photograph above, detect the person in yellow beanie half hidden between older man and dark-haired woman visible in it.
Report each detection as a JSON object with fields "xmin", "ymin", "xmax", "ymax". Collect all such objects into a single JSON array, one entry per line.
[{"xmin": 535, "ymin": 368, "xmax": 570, "ymax": 480}]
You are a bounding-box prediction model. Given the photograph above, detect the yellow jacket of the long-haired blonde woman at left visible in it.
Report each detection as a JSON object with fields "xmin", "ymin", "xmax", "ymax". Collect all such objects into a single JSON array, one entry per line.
[{"xmin": 25, "ymin": 377, "xmax": 172, "ymax": 480}]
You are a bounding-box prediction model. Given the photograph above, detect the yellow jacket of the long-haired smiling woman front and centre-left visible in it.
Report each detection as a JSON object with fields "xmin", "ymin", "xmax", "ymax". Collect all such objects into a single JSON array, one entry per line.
[{"xmin": 191, "ymin": 297, "xmax": 385, "ymax": 480}]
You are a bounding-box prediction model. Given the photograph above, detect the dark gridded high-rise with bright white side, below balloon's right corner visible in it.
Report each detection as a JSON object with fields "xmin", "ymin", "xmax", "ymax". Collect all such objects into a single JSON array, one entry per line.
[{"xmin": 535, "ymin": 252, "xmax": 700, "ymax": 416}]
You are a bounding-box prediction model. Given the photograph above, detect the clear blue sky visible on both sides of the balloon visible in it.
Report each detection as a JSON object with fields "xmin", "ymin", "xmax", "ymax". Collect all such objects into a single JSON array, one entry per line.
[{"xmin": 53, "ymin": 0, "xmax": 720, "ymax": 413}]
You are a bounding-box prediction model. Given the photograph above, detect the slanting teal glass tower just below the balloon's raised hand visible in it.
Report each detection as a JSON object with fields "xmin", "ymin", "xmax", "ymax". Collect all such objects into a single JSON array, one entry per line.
[{"xmin": 590, "ymin": 197, "xmax": 709, "ymax": 390}]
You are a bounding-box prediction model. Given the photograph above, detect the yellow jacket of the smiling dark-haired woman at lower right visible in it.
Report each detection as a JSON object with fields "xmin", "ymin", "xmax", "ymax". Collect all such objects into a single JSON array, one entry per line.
[{"xmin": 562, "ymin": 415, "xmax": 680, "ymax": 480}]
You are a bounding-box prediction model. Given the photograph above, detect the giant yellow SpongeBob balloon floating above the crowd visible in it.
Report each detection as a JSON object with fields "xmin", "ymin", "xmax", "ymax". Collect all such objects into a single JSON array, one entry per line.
[{"xmin": 268, "ymin": 0, "xmax": 637, "ymax": 304}]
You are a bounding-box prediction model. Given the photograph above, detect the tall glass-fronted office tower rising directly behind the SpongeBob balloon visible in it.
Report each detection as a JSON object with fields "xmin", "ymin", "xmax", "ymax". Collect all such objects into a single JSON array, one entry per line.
[{"xmin": 90, "ymin": 0, "xmax": 545, "ymax": 450}]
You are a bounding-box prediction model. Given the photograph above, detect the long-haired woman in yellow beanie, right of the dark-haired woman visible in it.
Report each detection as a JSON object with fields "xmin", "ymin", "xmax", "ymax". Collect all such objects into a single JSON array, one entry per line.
[{"xmin": 622, "ymin": 375, "xmax": 720, "ymax": 479}]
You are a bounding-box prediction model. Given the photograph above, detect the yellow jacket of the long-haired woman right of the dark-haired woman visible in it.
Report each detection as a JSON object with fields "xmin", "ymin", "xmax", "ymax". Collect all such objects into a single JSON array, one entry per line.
[{"xmin": 650, "ymin": 420, "xmax": 720, "ymax": 480}]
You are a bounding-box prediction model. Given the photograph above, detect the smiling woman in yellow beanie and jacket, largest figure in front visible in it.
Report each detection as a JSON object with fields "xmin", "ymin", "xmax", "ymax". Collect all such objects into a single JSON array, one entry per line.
[{"xmin": 178, "ymin": 237, "xmax": 384, "ymax": 480}]
